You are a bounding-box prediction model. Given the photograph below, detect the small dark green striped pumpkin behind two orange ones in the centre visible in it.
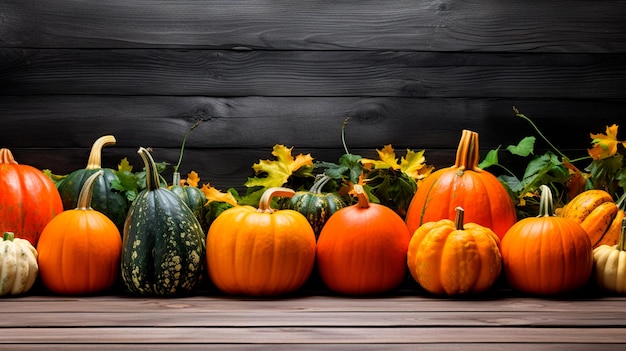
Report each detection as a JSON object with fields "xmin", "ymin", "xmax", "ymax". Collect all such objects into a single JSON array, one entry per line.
[{"xmin": 280, "ymin": 175, "xmax": 346, "ymax": 239}]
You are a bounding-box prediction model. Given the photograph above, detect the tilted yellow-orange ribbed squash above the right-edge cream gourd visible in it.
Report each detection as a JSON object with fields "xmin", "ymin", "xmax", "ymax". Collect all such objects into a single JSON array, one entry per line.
[{"xmin": 559, "ymin": 189, "xmax": 624, "ymax": 248}]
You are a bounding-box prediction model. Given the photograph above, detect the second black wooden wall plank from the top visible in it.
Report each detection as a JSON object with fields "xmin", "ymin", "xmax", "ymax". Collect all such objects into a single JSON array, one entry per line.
[{"xmin": 0, "ymin": 49, "xmax": 626, "ymax": 99}]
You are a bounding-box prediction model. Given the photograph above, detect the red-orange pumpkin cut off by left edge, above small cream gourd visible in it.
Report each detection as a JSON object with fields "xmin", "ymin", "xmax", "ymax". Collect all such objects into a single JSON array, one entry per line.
[{"xmin": 0, "ymin": 148, "xmax": 63, "ymax": 246}]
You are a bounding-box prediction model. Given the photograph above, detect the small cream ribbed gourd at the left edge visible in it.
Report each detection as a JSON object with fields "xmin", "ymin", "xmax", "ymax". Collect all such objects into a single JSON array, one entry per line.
[{"xmin": 0, "ymin": 232, "xmax": 39, "ymax": 296}]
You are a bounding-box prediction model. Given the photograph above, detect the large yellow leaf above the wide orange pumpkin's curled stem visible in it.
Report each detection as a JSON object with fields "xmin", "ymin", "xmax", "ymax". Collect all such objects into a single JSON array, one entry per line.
[{"xmin": 245, "ymin": 144, "xmax": 313, "ymax": 188}]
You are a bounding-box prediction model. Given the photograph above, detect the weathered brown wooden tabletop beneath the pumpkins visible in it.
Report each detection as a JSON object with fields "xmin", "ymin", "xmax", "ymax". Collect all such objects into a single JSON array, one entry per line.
[{"xmin": 0, "ymin": 280, "xmax": 626, "ymax": 351}]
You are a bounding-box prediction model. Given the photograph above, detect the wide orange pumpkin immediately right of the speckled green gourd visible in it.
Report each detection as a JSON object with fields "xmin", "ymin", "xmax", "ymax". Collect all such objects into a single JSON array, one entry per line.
[{"xmin": 206, "ymin": 188, "xmax": 315, "ymax": 296}]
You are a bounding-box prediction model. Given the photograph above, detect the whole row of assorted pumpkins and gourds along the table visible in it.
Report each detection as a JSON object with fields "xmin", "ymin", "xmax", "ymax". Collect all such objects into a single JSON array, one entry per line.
[{"xmin": 0, "ymin": 130, "xmax": 626, "ymax": 296}]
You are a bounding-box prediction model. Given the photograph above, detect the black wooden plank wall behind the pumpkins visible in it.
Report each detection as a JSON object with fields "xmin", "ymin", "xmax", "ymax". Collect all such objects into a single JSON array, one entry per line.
[{"xmin": 0, "ymin": 0, "xmax": 626, "ymax": 189}]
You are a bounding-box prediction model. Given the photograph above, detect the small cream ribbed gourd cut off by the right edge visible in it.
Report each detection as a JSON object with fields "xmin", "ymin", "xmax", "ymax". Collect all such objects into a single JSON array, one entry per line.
[{"xmin": 593, "ymin": 218, "xmax": 626, "ymax": 294}]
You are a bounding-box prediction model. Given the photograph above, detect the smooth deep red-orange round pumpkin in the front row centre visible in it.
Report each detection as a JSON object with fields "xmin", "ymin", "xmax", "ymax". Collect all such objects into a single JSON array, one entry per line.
[{"xmin": 317, "ymin": 185, "xmax": 411, "ymax": 295}]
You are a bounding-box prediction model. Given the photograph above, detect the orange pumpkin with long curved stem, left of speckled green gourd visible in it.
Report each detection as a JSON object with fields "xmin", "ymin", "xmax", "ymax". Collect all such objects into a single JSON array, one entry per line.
[{"xmin": 37, "ymin": 170, "xmax": 122, "ymax": 294}]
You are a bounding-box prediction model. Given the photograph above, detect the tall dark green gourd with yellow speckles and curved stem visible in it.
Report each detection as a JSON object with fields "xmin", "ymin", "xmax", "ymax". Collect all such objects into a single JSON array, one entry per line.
[{"xmin": 122, "ymin": 148, "xmax": 205, "ymax": 297}]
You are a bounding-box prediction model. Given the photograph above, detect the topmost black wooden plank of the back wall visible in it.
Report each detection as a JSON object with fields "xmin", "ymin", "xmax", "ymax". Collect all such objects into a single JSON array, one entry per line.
[{"xmin": 0, "ymin": 0, "xmax": 626, "ymax": 53}]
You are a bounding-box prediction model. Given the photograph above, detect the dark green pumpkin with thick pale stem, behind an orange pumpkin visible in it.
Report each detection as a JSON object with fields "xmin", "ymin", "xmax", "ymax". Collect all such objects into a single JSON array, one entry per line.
[{"xmin": 57, "ymin": 135, "xmax": 130, "ymax": 233}]
